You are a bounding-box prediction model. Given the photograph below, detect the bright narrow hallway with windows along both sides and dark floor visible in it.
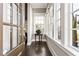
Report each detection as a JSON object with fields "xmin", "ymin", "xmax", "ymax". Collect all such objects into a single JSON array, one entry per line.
[{"xmin": 0, "ymin": 3, "xmax": 79, "ymax": 56}]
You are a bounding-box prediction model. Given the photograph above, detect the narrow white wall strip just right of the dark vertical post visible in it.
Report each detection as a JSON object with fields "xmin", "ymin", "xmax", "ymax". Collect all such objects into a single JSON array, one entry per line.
[{"xmin": 27, "ymin": 3, "xmax": 32, "ymax": 45}]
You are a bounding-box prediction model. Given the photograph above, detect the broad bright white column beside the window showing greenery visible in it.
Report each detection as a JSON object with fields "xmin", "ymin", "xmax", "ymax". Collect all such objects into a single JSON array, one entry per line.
[{"xmin": 64, "ymin": 4, "xmax": 70, "ymax": 46}]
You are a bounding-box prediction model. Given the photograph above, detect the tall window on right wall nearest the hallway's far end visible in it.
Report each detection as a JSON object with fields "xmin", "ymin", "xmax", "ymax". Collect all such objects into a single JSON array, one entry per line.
[{"xmin": 48, "ymin": 5, "xmax": 54, "ymax": 37}]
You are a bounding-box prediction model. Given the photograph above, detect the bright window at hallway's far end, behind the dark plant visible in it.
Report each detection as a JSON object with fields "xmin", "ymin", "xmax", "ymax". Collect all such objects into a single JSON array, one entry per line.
[{"xmin": 34, "ymin": 13, "xmax": 45, "ymax": 33}]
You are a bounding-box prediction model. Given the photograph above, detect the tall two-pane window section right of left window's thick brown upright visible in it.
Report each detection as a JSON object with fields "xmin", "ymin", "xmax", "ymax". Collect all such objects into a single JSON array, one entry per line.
[{"xmin": 12, "ymin": 4, "xmax": 18, "ymax": 48}]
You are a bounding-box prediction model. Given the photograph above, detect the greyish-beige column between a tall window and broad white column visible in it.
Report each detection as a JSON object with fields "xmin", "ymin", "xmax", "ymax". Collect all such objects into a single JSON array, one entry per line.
[{"xmin": 60, "ymin": 3, "xmax": 65, "ymax": 45}]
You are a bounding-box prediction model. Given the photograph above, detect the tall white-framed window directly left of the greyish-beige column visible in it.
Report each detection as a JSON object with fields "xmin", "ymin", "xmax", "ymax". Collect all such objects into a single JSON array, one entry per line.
[{"xmin": 56, "ymin": 3, "xmax": 61, "ymax": 43}]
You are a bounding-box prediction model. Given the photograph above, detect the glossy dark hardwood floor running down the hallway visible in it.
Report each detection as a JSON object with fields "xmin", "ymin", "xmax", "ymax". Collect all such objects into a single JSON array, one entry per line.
[{"xmin": 21, "ymin": 42, "xmax": 52, "ymax": 56}]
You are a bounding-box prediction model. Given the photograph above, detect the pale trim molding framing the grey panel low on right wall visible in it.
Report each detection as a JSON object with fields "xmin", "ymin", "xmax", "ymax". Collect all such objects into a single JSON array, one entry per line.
[{"xmin": 46, "ymin": 35, "xmax": 75, "ymax": 56}]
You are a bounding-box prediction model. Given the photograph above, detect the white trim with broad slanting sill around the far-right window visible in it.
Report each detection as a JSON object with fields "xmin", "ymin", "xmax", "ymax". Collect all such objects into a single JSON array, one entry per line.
[{"xmin": 65, "ymin": 5, "xmax": 79, "ymax": 56}]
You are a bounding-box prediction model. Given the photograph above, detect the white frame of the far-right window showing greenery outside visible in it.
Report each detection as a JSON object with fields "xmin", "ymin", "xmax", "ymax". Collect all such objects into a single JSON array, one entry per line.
[{"xmin": 69, "ymin": 3, "xmax": 79, "ymax": 52}]
